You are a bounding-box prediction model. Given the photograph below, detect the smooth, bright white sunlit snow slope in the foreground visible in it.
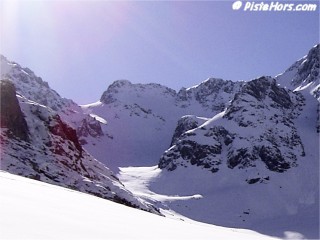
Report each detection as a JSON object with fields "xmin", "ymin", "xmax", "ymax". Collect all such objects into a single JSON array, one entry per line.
[{"xmin": 0, "ymin": 171, "xmax": 274, "ymax": 240}]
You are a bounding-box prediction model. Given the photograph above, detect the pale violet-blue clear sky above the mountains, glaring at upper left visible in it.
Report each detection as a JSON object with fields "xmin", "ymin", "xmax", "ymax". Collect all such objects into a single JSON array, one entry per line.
[{"xmin": 0, "ymin": 0, "xmax": 320, "ymax": 104}]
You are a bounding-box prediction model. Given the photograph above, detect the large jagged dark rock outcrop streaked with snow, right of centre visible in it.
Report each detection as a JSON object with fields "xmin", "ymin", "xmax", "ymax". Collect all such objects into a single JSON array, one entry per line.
[{"xmin": 159, "ymin": 77, "xmax": 305, "ymax": 172}]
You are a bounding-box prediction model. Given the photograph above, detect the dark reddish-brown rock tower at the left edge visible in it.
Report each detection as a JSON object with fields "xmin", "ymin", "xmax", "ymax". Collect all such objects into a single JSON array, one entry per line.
[{"xmin": 0, "ymin": 80, "xmax": 29, "ymax": 141}]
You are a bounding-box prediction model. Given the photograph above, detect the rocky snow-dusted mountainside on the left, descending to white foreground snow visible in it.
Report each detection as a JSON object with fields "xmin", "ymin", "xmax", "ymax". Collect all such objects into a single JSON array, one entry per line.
[{"xmin": 0, "ymin": 58, "xmax": 156, "ymax": 212}]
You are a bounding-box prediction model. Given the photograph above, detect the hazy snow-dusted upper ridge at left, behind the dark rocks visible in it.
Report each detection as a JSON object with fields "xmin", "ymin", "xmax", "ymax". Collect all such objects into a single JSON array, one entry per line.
[{"xmin": 0, "ymin": 55, "xmax": 103, "ymax": 138}]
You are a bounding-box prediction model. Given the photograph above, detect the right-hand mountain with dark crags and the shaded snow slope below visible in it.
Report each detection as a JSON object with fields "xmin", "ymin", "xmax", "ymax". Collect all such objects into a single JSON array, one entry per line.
[{"xmin": 150, "ymin": 45, "xmax": 320, "ymax": 238}]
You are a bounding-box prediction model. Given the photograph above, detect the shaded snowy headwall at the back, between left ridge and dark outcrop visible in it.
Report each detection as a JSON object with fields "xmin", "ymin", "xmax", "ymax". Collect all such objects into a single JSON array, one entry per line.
[{"xmin": 82, "ymin": 78, "xmax": 243, "ymax": 171}]
